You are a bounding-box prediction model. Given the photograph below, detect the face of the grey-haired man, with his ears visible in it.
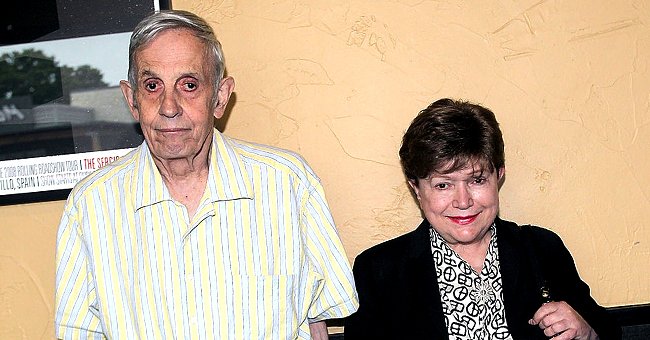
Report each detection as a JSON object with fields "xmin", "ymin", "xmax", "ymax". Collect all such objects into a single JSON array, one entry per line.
[{"xmin": 120, "ymin": 29, "xmax": 233, "ymax": 161}]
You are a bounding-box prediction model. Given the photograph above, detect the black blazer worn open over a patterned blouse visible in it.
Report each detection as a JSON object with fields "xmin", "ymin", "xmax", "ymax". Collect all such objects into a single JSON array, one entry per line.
[{"xmin": 344, "ymin": 218, "xmax": 621, "ymax": 340}]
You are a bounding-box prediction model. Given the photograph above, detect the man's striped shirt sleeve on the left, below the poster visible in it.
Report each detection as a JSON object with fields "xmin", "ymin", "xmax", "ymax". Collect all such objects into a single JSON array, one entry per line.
[{"xmin": 55, "ymin": 202, "xmax": 105, "ymax": 339}]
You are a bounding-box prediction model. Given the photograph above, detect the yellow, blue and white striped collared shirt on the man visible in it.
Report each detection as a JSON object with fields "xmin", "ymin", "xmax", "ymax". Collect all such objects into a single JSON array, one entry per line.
[{"xmin": 55, "ymin": 130, "xmax": 358, "ymax": 339}]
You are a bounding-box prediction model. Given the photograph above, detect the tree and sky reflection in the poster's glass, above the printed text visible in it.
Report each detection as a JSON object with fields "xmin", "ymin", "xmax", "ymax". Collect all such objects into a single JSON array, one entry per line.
[{"xmin": 0, "ymin": 33, "xmax": 142, "ymax": 161}]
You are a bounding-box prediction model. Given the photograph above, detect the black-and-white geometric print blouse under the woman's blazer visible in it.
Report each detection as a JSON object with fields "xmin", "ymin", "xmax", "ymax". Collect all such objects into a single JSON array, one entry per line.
[{"xmin": 429, "ymin": 224, "xmax": 512, "ymax": 340}]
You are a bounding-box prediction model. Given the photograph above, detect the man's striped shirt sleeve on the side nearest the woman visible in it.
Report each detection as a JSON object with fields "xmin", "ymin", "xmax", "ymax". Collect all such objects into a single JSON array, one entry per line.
[{"xmin": 301, "ymin": 179, "xmax": 359, "ymax": 322}]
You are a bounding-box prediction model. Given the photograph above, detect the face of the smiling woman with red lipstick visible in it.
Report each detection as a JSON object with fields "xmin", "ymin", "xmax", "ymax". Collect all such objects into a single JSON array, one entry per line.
[{"xmin": 409, "ymin": 166, "xmax": 505, "ymax": 248}]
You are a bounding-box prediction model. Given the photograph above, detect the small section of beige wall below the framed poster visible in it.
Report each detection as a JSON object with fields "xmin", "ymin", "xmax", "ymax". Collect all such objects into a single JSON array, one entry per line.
[{"xmin": 0, "ymin": 202, "xmax": 64, "ymax": 340}]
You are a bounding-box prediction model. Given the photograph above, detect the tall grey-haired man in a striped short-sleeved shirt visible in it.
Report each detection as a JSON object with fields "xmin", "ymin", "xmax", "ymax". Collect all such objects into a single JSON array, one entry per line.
[{"xmin": 56, "ymin": 11, "xmax": 358, "ymax": 339}]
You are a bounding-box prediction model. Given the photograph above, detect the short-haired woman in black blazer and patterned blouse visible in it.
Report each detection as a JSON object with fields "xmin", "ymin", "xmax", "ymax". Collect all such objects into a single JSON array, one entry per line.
[{"xmin": 345, "ymin": 99, "xmax": 620, "ymax": 340}]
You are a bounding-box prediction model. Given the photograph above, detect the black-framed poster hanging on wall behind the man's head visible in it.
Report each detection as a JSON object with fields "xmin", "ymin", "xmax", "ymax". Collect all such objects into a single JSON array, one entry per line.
[{"xmin": 0, "ymin": 0, "xmax": 171, "ymax": 205}]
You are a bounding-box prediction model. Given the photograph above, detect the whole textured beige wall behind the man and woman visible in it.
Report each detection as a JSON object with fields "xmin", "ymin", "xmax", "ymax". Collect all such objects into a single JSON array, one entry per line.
[{"xmin": 0, "ymin": 0, "xmax": 650, "ymax": 339}]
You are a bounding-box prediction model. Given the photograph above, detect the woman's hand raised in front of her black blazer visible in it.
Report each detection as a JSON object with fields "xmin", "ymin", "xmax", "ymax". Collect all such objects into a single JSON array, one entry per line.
[{"xmin": 528, "ymin": 301, "xmax": 598, "ymax": 340}]
